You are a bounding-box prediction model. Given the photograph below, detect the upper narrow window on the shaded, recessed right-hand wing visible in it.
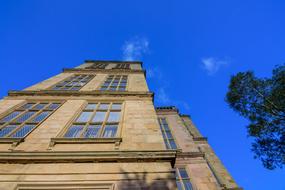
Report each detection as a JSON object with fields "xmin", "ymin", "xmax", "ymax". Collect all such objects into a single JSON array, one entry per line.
[{"xmin": 158, "ymin": 118, "xmax": 177, "ymax": 149}]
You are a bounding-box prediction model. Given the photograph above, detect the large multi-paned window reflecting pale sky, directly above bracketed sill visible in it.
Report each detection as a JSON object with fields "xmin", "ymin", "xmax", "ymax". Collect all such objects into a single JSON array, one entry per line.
[{"xmin": 64, "ymin": 103, "xmax": 122, "ymax": 138}]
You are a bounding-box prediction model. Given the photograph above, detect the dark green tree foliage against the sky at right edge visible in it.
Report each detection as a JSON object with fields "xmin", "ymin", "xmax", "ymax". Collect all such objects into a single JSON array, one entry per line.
[{"xmin": 226, "ymin": 64, "xmax": 285, "ymax": 169}]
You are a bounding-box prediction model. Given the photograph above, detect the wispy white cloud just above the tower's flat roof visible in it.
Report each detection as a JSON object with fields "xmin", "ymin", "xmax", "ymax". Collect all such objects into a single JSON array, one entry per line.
[{"xmin": 122, "ymin": 36, "xmax": 149, "ymax": 61}]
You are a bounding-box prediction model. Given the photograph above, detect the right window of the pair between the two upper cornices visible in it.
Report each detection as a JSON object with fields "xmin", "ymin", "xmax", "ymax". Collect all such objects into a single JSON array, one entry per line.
[{"xmin": 100, "ymin": 75, "xmax": 128, "ymax": 91}]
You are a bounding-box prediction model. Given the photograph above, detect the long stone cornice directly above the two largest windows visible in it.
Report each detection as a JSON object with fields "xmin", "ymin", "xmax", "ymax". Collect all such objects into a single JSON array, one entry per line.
[{"xmin": 8, "ymin": 90, "xmax": 153, "ymax": 98}]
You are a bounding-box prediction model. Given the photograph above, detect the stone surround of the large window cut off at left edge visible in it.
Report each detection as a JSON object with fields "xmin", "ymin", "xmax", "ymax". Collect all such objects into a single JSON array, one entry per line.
[{"xmin": 0, "ymin": 99, "xmax": 65, "ymax": 149}]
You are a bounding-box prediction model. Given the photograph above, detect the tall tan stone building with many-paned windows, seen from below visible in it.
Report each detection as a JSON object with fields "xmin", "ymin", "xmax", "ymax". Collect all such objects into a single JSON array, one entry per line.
[{"xmin": 0, "ymin": 61, "xmax": 240, "ymax": 190}]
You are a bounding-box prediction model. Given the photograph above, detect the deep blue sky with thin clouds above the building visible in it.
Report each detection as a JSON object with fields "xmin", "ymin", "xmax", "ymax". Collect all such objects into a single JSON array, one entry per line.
[{"xmin": 0, "ymin": 0, "xmax": 285, "ymax": 190}]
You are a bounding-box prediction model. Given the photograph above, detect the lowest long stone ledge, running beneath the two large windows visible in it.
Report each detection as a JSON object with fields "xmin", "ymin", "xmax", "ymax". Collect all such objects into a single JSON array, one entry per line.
[{"xmin": 0, "ymin": 150, "xmax": 176, "ymax": 164}]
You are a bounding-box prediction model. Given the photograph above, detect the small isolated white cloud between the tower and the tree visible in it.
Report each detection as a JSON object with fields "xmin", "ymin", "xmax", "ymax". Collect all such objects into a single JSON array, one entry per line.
[{"xmin": 202, "ymin": 57, "xmax": 229, "ymax": 75}]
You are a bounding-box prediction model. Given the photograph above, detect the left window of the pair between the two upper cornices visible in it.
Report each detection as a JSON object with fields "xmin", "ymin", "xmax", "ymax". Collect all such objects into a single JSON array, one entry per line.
[{"xmin": 52, "ymin": 75, "xmax": 94, "ymax": 91}]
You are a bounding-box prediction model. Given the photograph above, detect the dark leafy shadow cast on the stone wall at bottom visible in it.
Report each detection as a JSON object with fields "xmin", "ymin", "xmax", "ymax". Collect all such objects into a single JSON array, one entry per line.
[{"xmin": 117, "ymin": 170, "xmax": 177, "ymax": 190}]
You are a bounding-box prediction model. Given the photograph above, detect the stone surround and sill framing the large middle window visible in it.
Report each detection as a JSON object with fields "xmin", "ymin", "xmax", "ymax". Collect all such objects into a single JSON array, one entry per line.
[{"xmin": 49, "ymin": 100, "xmax": 125, "ymax": 149}]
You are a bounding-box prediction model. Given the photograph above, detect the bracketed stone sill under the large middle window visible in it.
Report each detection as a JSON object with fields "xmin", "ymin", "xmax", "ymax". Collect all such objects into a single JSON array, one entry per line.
[{"xmin": 50, "ymin": 137, "xmax": 122, "ymax": 147}]
